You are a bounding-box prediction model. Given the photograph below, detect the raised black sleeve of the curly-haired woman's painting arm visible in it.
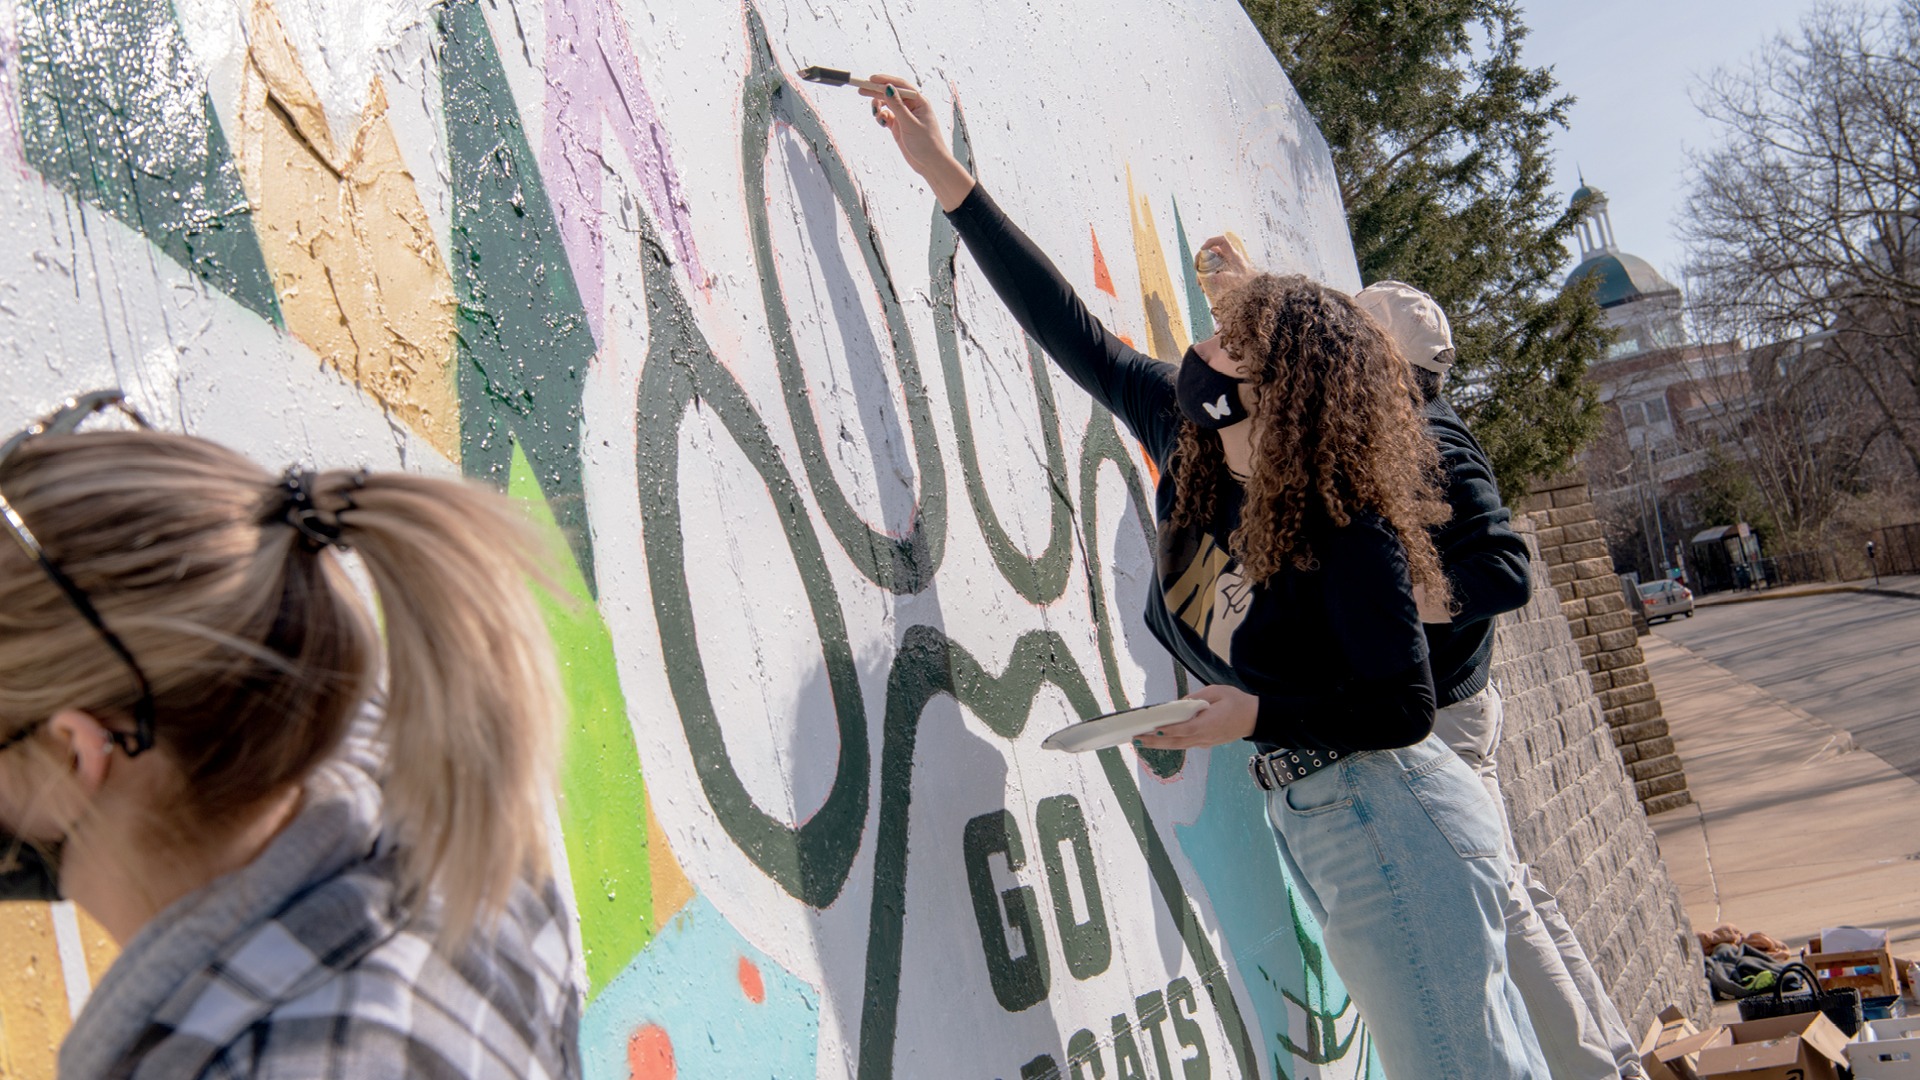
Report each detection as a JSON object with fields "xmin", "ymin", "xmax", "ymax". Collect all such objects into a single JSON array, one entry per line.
[{"xmin": 947, "ymin": 183, "xmax": 1179, "ymax": 457}]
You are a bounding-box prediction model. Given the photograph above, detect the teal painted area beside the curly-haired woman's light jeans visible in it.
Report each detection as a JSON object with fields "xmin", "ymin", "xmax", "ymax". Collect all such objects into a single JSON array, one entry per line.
[{"xmin": 1173, "ymin": 746, "xmax": 1380, "ymax": 1080}]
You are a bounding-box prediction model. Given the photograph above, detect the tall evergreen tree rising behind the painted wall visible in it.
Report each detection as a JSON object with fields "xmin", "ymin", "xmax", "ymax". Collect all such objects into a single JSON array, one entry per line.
[{"xmin": 1242, "ymin": 0, "xmax": 1611, "ymax": 500}]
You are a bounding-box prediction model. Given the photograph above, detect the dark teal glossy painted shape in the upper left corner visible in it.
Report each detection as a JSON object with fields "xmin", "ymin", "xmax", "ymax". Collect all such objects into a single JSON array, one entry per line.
[{"xmin": 15, "ymin": 0, "xmax": 280, "ymax": 325}]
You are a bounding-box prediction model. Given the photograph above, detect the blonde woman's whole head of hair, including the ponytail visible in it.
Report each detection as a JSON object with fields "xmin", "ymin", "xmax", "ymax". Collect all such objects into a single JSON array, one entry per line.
[{"xmin": 0, "ymin": 430, "xmax": 563, "ymax": 942}]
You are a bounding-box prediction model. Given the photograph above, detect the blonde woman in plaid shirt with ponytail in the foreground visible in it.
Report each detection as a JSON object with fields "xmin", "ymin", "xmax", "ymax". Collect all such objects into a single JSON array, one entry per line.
[{"xmin": 0, "ymin": 392, "xmax": 580, "ymax": 1080}]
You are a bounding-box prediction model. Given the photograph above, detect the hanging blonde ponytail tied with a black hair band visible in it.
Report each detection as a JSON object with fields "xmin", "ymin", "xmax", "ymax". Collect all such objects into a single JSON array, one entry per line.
[{"xmin": 313, "ymin": 473, "xmax": 563, "ymax": 940}]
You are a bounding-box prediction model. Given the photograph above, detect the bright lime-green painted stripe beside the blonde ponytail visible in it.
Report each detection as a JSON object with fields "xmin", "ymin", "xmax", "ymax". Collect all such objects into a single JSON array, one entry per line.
[{"xmin": 507, "ymin": 446, "xmax": 657, "ymax": 994}]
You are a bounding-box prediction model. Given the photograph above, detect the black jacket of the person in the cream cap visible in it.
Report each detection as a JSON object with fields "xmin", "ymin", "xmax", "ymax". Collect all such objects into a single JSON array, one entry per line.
[{"xmin": 1423, "ymin": 390, "xmax": 1532, "ymax": 705}]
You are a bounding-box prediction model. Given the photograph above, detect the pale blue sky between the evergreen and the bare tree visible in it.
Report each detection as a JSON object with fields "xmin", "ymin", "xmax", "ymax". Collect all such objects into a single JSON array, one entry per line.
[{"xmin": 1521, "ymin": 0, "xmax": 1812, "ymax": 281}]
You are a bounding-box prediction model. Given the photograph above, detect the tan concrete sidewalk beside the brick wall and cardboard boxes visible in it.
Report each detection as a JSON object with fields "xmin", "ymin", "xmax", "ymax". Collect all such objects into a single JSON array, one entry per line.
[{"xmin": 1640, "ymin": 630, "xmax": 1920, "ymax": 983}]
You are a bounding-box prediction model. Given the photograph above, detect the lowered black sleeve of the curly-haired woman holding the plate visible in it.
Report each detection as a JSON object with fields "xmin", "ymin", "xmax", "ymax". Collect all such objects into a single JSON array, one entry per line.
[{"xmin": 1252, "ymin": 517, "xmax": 1434, "ymax": 753}]
